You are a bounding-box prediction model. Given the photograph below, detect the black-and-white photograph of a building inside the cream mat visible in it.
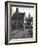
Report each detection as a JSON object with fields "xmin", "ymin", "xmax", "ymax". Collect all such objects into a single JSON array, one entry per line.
[{"xmin": 11, "ymin": 7, "xmax": 33, "ymax": 39}]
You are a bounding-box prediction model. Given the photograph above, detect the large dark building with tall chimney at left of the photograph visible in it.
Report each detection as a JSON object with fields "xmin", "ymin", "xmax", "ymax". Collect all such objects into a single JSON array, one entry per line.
[{"xmin": 12, "ymin": 8, "xmax": 25, "ymax": 30}]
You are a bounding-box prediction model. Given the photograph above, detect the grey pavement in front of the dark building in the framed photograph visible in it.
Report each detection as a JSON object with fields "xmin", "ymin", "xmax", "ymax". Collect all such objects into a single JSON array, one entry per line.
[{"xmin": 11, "ymin": 29, "xmax": 31, "ymax": 39}]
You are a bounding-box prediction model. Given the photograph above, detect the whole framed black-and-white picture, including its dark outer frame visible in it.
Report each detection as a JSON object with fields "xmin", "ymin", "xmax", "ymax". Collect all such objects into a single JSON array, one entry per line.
[{"xmin": 5, "ymin": 2, "xmax": 37, "ymax": 44}]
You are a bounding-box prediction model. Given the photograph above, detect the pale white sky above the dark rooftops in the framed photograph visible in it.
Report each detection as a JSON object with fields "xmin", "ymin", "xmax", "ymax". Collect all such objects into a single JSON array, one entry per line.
[{"xmin": 11, "ymin": 7, "xmax": 35, "ymax": 17}]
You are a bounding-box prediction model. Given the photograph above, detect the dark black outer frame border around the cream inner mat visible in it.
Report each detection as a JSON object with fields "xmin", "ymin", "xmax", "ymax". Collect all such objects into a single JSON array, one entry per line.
[{"xmin": 5, "ymin": 1, "xmax": 37, "ymax": 45}]
